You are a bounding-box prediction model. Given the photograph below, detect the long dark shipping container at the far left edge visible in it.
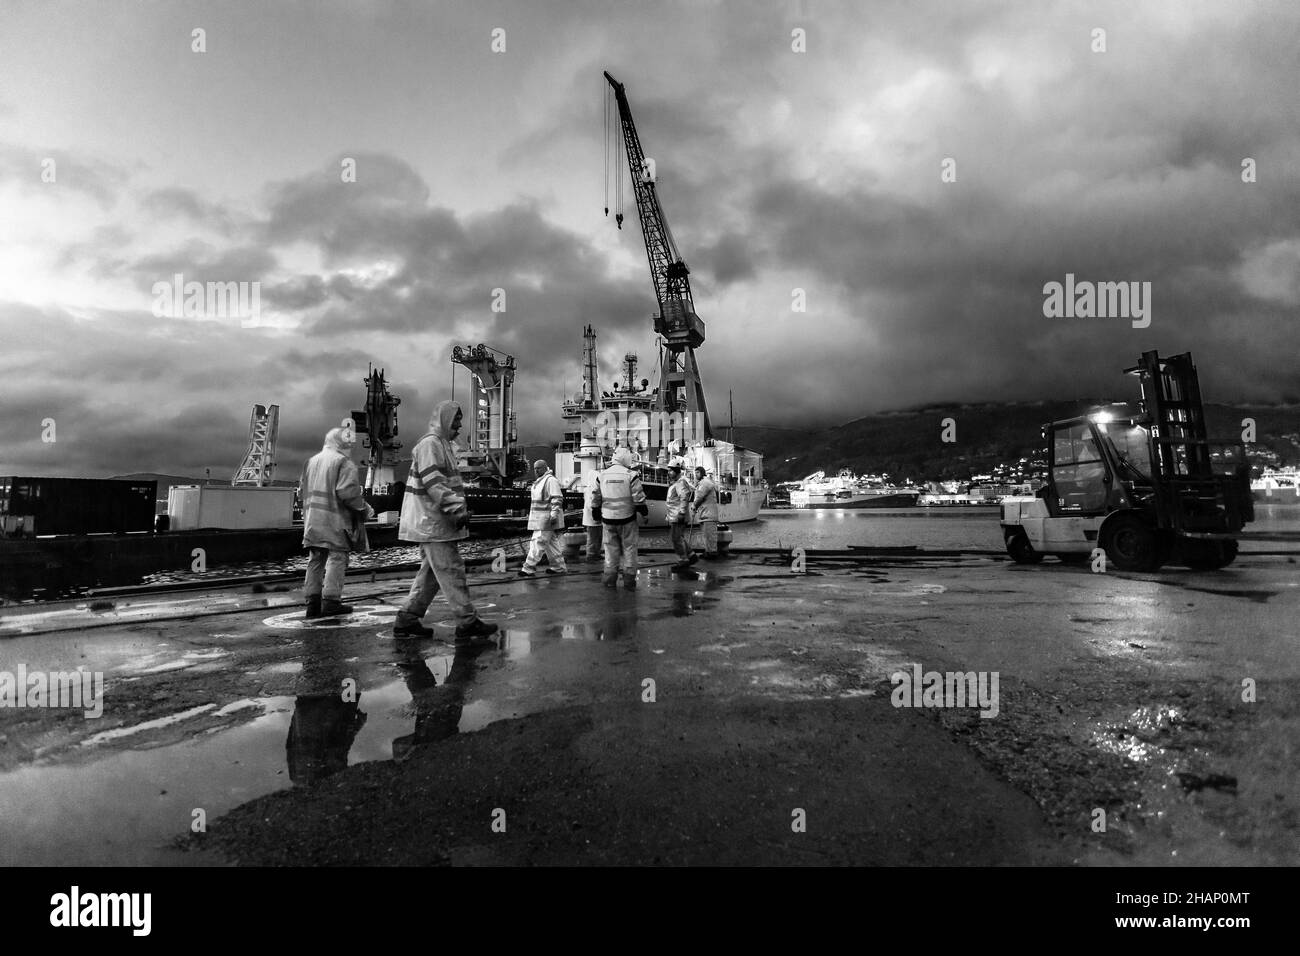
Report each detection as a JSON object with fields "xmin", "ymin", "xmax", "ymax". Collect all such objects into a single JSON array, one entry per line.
[{"xmin": 0, "ymin": 477, "xmax": 157, "ymax": 535}]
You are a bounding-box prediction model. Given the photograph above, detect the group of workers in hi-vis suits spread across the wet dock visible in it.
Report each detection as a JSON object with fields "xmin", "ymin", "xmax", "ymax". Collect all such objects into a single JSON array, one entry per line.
[{"xmin": 300, "ymin": 401, "xmax": 718, "ymax": 646}]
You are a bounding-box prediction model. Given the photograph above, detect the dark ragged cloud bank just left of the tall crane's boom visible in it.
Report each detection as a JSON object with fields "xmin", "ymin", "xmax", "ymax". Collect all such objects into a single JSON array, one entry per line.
[{"xmin": 257, "ymin": 156, "xmax": 654, "ymax": 369}]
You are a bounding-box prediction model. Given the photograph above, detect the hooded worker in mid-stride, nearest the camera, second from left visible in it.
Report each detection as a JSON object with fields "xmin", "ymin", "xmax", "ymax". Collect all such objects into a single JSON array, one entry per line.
[{"xmin": 393, "ymin": 402, "xmax": 498, "ymax": 646}]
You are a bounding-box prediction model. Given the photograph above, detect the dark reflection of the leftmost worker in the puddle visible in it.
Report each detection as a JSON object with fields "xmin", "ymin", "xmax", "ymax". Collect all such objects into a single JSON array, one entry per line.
[{"xmin": 285, "ymin": 634, "xmax": 365, "ymax": 784}]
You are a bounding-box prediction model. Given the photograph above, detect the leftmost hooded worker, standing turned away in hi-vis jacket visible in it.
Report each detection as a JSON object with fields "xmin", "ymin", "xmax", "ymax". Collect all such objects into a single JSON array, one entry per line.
[{"xmin": 298, "ymin": 428, "xmax": 374, "ymax": 618}]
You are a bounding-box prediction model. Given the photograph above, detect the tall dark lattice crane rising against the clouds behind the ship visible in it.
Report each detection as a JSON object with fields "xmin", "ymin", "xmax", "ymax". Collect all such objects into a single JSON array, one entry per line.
[{"xmin": 605, "ymin": 72, "xmax": 712, "ymax": 440}]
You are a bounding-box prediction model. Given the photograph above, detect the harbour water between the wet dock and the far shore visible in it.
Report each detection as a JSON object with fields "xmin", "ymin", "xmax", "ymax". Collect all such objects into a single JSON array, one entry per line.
[{"xmin": 147, "ymin": 505, "xmax": 1300, "ymax": 583}]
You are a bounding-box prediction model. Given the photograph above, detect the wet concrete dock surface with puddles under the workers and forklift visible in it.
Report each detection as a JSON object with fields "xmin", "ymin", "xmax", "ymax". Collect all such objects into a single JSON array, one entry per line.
[{"xmin": 0, "ymin": 546, "xmax": 1300, "ymax": 865}]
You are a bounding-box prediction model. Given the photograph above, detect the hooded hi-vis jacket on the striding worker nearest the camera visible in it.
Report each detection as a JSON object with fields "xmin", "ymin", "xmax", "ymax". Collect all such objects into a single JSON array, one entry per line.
[{"xmin": 398, "ymin": 402, "xmax": 469, "ymax": 541}]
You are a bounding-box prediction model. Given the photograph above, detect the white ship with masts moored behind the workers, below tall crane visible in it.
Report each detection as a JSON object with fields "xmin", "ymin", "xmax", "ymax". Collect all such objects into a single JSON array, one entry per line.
[{"xmin": 555, "ymin": 325, "xmax": 767, "ymax": 528}]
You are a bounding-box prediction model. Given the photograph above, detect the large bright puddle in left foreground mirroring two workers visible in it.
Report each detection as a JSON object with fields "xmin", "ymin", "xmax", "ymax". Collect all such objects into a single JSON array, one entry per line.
[{"xmin": 0, "ymin": 648, "xmax": 519, "ymax": 866}]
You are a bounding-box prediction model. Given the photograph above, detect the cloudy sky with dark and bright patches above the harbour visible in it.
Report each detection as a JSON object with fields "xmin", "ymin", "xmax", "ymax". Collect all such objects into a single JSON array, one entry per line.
[{"xmin": 0, "ymin": 0, "xmax": 1300, "ymax": 477}]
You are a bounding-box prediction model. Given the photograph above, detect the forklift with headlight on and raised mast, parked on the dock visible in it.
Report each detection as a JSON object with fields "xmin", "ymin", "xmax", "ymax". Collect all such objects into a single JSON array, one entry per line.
[{"xmin": 1002, "ymin": 351, "xmax": 1255, "ymax": 571}]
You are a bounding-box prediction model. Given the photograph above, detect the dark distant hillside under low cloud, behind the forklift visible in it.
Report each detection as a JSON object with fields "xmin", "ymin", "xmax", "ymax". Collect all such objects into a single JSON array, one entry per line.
[{"xmin": 736, "ymin": 401, "xmax": 1300, "ymax": 484}]
